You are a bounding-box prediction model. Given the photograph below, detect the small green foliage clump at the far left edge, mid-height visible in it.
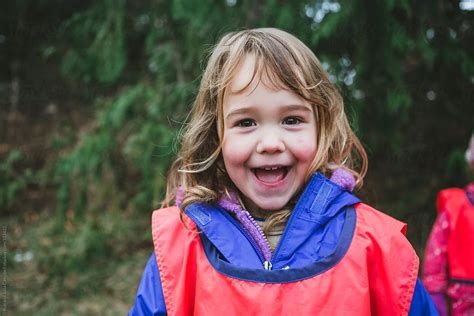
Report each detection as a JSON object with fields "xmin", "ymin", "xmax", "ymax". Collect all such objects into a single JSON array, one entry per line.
[{"xmin": 0, "ymin": 150, "xmax": 33, "ymax": 209}]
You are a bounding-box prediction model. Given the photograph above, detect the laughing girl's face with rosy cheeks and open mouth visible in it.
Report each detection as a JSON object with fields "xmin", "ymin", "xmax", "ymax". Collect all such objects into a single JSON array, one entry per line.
[{"xmin": 222, "ymin": 55, "xmax": 316, "ymax": 215}]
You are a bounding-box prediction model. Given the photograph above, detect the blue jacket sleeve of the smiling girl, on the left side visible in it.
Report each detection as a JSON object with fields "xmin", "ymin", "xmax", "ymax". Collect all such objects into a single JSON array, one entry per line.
[{"xmin": 128, "ymin": 253, "xmax": 166, "ymax": 316}]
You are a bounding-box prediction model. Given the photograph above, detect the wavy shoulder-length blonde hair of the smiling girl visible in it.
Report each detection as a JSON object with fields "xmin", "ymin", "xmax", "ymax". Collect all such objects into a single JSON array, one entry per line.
[{"xmin": 163, "ymin": 28, "xmax": 367, "ymax": 232}]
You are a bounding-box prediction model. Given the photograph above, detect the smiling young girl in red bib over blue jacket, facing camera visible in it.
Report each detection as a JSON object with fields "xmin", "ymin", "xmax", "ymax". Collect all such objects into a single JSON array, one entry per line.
[{"xmin": 130, "ymin": 29, "xmax": 436, "ymax": 315}]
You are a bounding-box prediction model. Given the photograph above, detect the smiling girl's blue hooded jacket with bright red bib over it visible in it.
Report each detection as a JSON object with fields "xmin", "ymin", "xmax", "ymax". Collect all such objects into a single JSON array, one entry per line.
[{"xmin": 129, "ymin": 174, "xmax": 437, "ymax": 315}]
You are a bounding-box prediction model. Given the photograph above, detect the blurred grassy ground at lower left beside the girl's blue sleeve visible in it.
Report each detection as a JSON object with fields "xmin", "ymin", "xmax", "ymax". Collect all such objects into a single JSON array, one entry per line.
[{"xmin": 2, "ymin": 207, "xmax": 152, "ymax": 315}]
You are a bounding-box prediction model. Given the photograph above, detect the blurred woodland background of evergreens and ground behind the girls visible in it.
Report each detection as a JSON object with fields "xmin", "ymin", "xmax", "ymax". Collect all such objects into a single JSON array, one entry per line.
[{"xmin": 0, "ymin": 0, "xmax": 474, "ymax": 315}]
